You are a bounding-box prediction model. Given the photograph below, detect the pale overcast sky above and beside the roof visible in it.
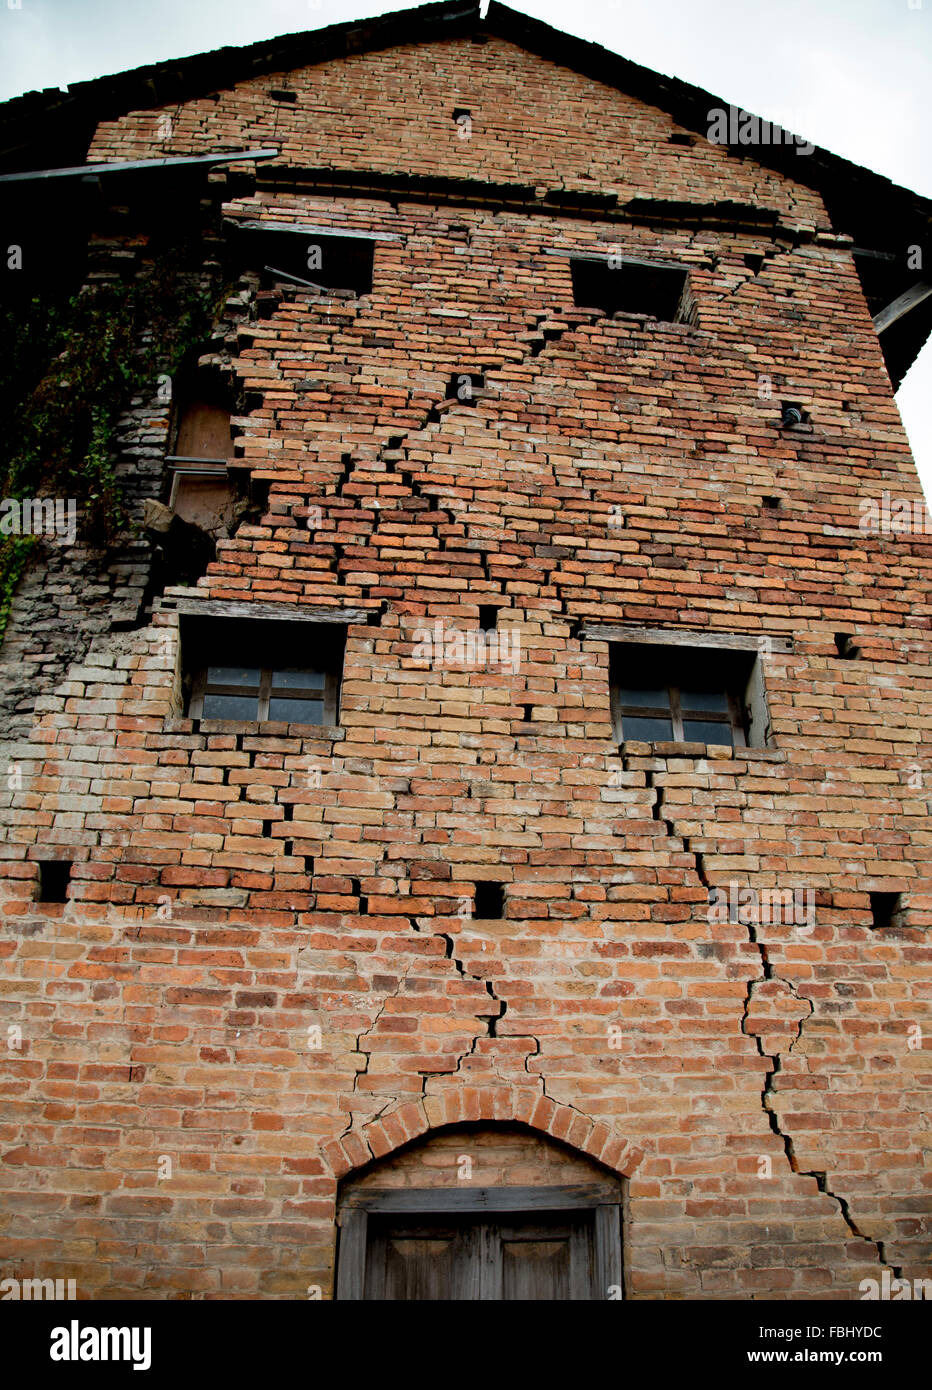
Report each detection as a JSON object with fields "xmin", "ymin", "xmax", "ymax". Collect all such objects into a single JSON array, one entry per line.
[{"xmin": 0, "ymin": 0, "xmax": 932, "ymax": 498}]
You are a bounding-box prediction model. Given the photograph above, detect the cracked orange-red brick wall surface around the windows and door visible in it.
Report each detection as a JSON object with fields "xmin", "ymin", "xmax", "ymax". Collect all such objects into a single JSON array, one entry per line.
[{"xmin": 0, "ymin": 32, "xmax": 932, "ymax": 1298}]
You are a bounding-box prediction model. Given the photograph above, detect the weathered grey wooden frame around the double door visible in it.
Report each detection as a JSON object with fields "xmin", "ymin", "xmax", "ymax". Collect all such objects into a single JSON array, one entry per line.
[{"xmin": 335, "ymin": 1183, "xmax": 624, "ymax": 1301}]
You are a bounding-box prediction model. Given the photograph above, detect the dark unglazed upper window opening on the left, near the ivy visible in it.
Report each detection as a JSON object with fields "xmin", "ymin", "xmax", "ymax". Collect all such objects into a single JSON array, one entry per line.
[{"xmin": 232, "ymin": 224, "xmax": 375, "ymax": 296}]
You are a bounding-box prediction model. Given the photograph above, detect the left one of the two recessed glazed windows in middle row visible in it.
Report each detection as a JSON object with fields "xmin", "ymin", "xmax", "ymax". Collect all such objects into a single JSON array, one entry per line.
[{"xmin": 181, "ymin": 614, "xmax": 346, "ymax": 726}]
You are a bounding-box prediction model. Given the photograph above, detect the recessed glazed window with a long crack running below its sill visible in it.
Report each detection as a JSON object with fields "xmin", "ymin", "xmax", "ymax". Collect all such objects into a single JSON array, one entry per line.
[{"xmin": 610, "ymin": 642, "xmax": 769, "ymax": 748}]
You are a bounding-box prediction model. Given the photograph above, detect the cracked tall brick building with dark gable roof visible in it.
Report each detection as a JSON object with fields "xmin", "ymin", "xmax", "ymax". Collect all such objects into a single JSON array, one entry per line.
[{"xmin": 0, "ymin": 3, "xmax": 932, "ymax": 1300}]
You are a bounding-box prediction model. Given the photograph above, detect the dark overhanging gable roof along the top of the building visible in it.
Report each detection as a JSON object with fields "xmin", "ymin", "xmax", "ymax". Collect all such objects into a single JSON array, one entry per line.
[{"xmin": 0, "ymin": 0, "xmax": 932, "ymax": 384}]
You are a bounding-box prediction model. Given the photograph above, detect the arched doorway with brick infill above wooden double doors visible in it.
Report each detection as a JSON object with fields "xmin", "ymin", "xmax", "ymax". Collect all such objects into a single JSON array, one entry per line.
[{"xmin": 336, "ymin": 1123, "xmax": 624, "ymax": 1301}]
